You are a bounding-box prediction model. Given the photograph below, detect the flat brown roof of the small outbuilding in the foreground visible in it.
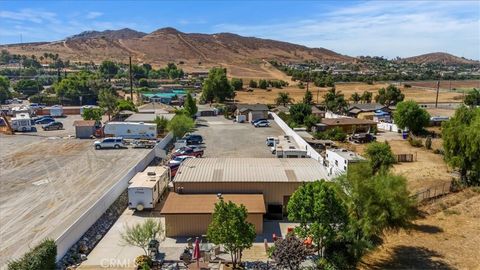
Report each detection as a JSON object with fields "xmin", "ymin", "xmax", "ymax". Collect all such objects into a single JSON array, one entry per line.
[{"xmin": 160, "ymin": 192, "xmax": 266, "ymax": 215}]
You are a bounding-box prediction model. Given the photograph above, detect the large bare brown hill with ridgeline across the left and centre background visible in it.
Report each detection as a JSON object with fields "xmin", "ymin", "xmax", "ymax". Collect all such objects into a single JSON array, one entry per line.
[{"xmin": 2, "ymin": 28, "xmax": 354, "ymax": 77}]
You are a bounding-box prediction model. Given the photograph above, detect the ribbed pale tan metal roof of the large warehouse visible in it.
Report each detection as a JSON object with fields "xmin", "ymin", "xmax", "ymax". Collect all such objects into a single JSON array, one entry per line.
[{"xmin": 173, "ymin": 158, "xmax": 327, "ymax": 183}]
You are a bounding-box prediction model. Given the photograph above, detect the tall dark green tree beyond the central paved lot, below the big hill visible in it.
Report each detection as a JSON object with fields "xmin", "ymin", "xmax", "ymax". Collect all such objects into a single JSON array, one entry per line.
[{"xmin": 202, "ymin": 68, "xmax": 234, "ymax": 102}]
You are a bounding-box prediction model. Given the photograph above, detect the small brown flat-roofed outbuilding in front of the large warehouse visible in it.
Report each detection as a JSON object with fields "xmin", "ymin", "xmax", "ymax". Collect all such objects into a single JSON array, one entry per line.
[{"xmin": 160, "ymin": 192, "xmax": 266, "ymax": 237}]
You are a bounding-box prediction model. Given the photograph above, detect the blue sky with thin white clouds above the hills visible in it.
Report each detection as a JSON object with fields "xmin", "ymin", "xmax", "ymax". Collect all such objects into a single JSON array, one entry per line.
[{"xmin": 0, "ymin": 0, "xmax": 480, "ymax": 59}]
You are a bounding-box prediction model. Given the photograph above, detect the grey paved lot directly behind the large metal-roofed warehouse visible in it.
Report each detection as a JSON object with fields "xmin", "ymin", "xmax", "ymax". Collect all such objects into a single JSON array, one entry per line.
[{"xmin": 195, "ymin": 116, "xmax": 284, "ymax": 158}]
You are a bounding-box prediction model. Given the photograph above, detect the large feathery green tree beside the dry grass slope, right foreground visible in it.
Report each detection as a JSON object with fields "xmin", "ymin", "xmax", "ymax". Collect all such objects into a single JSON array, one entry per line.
[{"xmin": 335, "ymin": 163, "xmax": 416, "ymax": 265}]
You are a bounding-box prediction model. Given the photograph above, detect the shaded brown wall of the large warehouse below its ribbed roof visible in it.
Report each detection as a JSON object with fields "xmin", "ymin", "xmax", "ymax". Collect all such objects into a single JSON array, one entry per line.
[{"xmin": 174, "ymin": 181, "xmax": 303, "ymax": 205}]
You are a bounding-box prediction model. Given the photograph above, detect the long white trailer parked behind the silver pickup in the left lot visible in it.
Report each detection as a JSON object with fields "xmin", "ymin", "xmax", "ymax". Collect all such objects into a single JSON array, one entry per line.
[{"xmin": 103, "ymin": 122, "xmax": 157, "ymax": 139}]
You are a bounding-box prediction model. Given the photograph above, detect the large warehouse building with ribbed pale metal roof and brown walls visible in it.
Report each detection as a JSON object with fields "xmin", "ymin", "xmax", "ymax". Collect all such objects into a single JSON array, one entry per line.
[{"xmin": 173, "ymin": 158, "xmax": 327, "ymax": 215}]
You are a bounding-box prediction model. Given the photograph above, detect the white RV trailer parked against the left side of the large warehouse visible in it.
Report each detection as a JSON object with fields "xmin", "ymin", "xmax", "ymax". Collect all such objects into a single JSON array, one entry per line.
[{"xmin": 128, "ymin": 166, "xmax": 170, "ymax": 211}]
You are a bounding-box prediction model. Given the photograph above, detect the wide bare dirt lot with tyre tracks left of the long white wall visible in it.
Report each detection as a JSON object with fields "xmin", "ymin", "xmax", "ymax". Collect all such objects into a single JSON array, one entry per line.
[{"xmin": 0, "ymin": 133, "xmax": 151, "ymax": 266}]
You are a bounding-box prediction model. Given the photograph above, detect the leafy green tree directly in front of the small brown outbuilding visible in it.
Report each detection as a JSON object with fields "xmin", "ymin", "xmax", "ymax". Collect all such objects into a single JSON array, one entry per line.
[{"xmin": 207, "ymin": 199, "xmax": 256, "ymax": 269}]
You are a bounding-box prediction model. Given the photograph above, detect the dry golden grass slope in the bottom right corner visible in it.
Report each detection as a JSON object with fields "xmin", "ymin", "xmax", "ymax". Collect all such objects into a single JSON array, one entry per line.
[{"xmin": 360, "ymin": 190, "xmax": 480, "ymax": 269}]
